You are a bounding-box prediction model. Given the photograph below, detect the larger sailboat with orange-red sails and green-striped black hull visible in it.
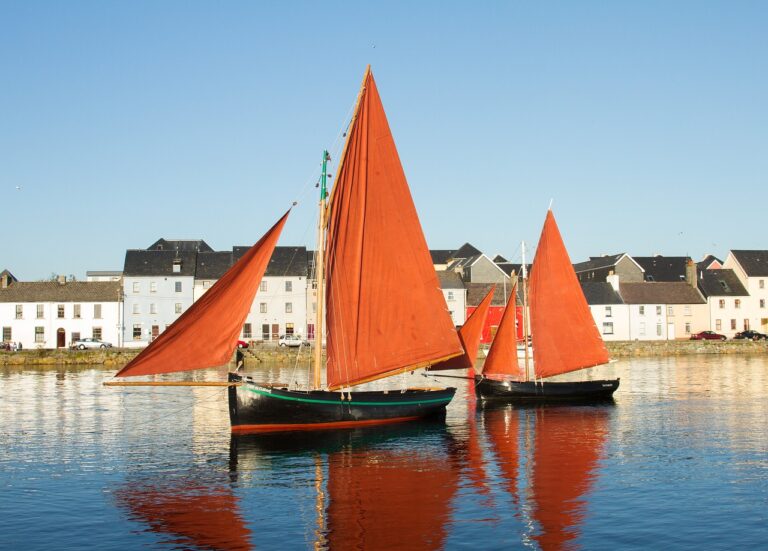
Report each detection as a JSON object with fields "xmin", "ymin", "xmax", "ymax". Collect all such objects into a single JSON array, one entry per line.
[{"xmin": 109, "ymin": 67, "xmax": 463, "ymax": 432}]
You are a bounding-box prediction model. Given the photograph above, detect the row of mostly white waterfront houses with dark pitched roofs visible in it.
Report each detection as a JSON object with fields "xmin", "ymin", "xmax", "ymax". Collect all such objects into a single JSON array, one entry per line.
[{"xmin": 0, "ymin": 239, "xmax": 768, "ymax": 348}]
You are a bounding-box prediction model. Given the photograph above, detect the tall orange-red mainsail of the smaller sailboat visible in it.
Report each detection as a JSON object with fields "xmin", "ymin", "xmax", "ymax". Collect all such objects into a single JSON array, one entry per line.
[{"xmin": 530, "ymin": 211, "xmax": 608, "ymax": 378}]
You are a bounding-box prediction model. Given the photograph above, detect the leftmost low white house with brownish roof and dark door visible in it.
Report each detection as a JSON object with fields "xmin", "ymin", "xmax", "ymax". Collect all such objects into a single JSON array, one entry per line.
[{"xmin": 0, "ymin": 273, "xmax": 122, "ymax": 349}]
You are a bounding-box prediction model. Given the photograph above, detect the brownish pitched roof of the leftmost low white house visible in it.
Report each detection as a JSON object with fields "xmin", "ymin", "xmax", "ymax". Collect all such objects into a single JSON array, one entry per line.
[{"xmin": 0, "ymin": 281, "xmax": 122, "ymax": 302}]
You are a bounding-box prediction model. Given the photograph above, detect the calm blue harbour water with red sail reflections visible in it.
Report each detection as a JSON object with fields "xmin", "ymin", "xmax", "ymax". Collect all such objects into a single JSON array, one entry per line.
[{"xmin": 0, "ymin": 356, "xmax": 768, "ymax": 550}]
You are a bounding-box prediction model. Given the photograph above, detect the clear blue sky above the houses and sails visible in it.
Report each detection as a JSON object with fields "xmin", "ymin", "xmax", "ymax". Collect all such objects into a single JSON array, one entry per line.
[{"xmin": 0, "ymin": 0, "xmax": 768, "ymax": 280}]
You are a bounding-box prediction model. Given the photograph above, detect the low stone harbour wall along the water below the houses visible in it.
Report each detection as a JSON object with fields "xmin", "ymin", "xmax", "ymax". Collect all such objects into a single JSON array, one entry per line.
[{"xmin": 0, "ymin": 340, "xmax": 768, "ymax": 366}]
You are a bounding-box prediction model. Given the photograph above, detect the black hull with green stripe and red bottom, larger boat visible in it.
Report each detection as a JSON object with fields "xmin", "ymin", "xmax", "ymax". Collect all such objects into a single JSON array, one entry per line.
[{"xmin": 229, "ymin": 373, "xmax": 456, "ymax": 432}]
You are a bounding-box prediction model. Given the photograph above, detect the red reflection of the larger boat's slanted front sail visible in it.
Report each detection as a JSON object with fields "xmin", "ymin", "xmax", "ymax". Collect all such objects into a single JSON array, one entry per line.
[{"xmin": 115, "ymin": 481, "xmax": 253, "ymax": 551}]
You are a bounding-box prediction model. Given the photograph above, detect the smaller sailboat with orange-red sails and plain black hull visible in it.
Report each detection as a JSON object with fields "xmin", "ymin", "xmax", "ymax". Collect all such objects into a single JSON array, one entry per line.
[{"xmin": 476, "ymin": 210, "xmax": 619, "ymax": 401}]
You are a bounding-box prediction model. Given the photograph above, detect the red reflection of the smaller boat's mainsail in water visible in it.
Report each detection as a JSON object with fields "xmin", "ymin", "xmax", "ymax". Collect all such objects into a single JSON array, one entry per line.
[{"xmin": 530, "ymin": 408, "xmax": 608, "ymax": 551}]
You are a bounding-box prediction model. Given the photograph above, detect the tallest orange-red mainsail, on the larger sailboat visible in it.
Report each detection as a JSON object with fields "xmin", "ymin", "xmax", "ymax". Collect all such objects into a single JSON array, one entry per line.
[{"xmin": 326, "ymin": 71, "xmax": 463, "ymax": 390}]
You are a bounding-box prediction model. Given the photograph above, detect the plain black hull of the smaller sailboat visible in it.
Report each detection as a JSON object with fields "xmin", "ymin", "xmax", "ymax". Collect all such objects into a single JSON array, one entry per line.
[{"xmin": 475, "ymin": 377, "xmax": 619, "ymax": 403}]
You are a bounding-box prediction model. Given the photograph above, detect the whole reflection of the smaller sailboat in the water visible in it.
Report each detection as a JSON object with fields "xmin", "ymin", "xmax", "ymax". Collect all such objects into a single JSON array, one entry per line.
[{"xmin": 480, "ymin": 404, "xmax": 614, "ymax": 550}]
